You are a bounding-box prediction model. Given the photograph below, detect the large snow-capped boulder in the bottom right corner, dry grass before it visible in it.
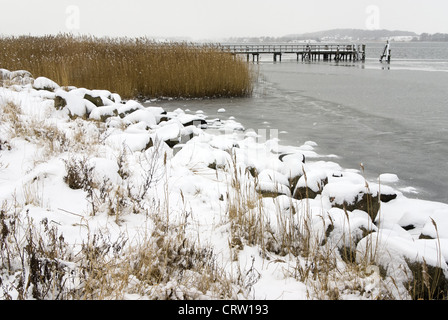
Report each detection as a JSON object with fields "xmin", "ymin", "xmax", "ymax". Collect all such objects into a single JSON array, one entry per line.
[{"xmin": 356, "ymin": 229, "xmax": 448, "ymax": 299}]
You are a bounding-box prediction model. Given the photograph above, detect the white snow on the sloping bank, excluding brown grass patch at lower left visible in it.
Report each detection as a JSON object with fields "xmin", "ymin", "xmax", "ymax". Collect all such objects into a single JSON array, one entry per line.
[{"xmin": 0, "ymin": 69, "xmax": 448, "ymax": 299}]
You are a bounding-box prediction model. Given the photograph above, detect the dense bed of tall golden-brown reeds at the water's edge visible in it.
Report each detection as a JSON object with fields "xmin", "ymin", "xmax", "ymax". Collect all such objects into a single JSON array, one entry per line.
[{"xmin": 0, "ymin": 34, "xmax": 253, "ymax": 98}]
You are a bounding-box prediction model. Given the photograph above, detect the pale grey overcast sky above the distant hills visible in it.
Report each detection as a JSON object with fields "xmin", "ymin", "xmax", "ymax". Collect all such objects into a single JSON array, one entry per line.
[{"xmin": 0, "ymin": 0, "xmax": 448, "ymax": 40}]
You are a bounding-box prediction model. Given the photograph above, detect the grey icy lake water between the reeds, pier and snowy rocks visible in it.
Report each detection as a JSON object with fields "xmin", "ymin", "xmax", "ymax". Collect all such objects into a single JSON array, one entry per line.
[{"xmin": 152, "ymin": 43, "xmax": 448, "ymax": 203}]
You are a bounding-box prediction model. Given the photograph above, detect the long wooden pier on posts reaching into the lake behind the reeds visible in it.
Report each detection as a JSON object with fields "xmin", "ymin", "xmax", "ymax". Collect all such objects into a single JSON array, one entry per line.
[{"xmin": 220, "ymin": 44, "xmax": 366, "ymax": 62}]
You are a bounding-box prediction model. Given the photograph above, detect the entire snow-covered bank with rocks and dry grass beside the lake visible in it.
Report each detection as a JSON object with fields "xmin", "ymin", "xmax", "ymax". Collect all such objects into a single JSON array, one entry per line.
[{"xmin": 0, "ymin": 69, "xmax": 448, "ymax": 299}]
